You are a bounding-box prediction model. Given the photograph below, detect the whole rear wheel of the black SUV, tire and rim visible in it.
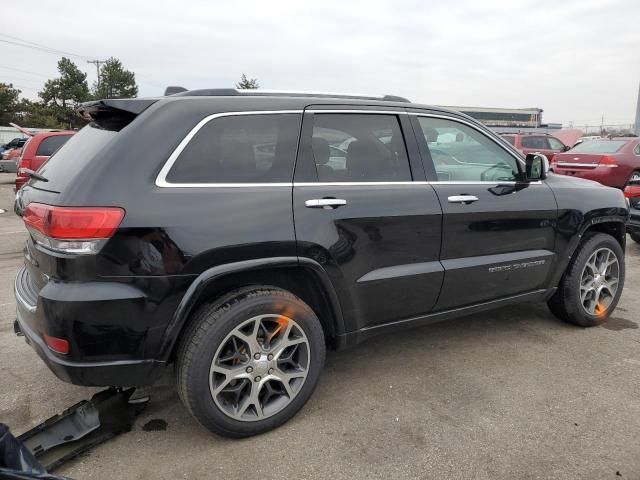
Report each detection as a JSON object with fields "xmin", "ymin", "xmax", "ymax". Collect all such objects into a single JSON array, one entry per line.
[{"xmin": 176, "ymin": 286, "xmax": 325, "ymax": 438}]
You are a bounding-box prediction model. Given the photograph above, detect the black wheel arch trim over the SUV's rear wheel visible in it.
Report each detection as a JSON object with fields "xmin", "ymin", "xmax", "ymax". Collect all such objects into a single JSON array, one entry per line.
[{"xmin": 159, "ymin": 257, "xmax": 345, "ymax": 362}]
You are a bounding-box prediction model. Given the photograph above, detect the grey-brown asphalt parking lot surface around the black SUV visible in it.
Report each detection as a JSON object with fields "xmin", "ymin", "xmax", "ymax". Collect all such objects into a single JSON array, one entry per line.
[{"xmin": 0, "ymin": 174, "xmax": 640, "ymax": 480}]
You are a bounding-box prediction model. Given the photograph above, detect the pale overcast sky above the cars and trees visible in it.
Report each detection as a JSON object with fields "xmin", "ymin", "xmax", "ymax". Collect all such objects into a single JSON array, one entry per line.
[{"xmin": 0, "ymin": 0, "xmax": 640, "ymax": 125}]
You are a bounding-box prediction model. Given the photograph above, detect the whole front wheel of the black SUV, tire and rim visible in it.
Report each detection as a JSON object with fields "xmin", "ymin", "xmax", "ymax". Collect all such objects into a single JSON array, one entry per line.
[{"xmin": 548, "ymin": 233, "xmax": 625, "ymax": 327}]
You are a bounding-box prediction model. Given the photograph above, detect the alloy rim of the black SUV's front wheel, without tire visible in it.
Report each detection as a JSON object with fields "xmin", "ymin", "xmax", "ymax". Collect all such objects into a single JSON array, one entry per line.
[{"xmin": 580, "ymin": 248, "xmax": 620, "ymax": 316}]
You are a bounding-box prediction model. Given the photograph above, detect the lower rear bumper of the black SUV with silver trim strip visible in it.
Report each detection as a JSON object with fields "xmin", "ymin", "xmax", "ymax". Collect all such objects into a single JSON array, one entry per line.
[{"xmin": 14, "ymin": 269, "xmax": 166, "ymax": 387}]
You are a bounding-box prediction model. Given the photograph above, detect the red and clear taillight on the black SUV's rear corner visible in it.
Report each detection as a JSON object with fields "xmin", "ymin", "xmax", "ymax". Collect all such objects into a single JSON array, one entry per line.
[{"xmin": 23, "ymin": 203, "xmax": 124, "ymax": 253}]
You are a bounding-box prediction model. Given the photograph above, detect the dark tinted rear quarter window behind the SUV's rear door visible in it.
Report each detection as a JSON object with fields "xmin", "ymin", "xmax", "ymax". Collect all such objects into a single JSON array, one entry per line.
[{"xmin": 167, "ymin": 114, "xmax": 300, "ymax": 183}]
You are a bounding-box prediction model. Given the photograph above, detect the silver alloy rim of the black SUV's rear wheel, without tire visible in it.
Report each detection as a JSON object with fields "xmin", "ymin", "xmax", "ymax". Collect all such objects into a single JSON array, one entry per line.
[{"xmin": 209, "ymin": 314, "xmax": 311, "ymax": 421}]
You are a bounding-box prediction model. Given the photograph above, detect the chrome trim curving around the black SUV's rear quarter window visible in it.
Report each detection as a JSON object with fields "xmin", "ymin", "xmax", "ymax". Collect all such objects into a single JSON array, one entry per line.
[{"xmin": 156, "ymin": 110, "xmax": 303, "ymax": 188}]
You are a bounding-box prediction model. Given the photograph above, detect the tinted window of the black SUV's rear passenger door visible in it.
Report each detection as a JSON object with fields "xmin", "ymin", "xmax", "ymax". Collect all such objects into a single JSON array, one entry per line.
[{"xmin": 312, "ymin": 113, "xmax": 411, "ymax": 182}]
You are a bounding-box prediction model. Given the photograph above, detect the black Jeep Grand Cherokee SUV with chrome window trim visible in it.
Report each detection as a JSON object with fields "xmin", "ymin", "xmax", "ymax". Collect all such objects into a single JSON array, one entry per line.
[{"xmin": 15, "ymin": 90, "xmax": 629, "ymax": 437}]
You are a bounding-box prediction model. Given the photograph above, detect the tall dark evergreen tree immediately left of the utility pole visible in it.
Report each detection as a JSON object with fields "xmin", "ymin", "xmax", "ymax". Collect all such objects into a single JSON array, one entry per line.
[{"xmin": 38, "ymin": 57, "xmax": 91, "ymax": 128}]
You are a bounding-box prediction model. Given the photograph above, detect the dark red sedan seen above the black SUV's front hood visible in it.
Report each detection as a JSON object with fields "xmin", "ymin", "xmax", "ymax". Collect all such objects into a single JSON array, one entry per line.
[{"xmin": 551, "ymin": 137, "xmax": 640, "ymax": 188}]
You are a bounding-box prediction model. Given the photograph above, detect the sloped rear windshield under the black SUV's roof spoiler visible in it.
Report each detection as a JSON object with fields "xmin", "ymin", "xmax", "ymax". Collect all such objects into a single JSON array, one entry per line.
[{"xmin": 35, "ymin": 123, "xmax": 118, "ymax": 192}]
